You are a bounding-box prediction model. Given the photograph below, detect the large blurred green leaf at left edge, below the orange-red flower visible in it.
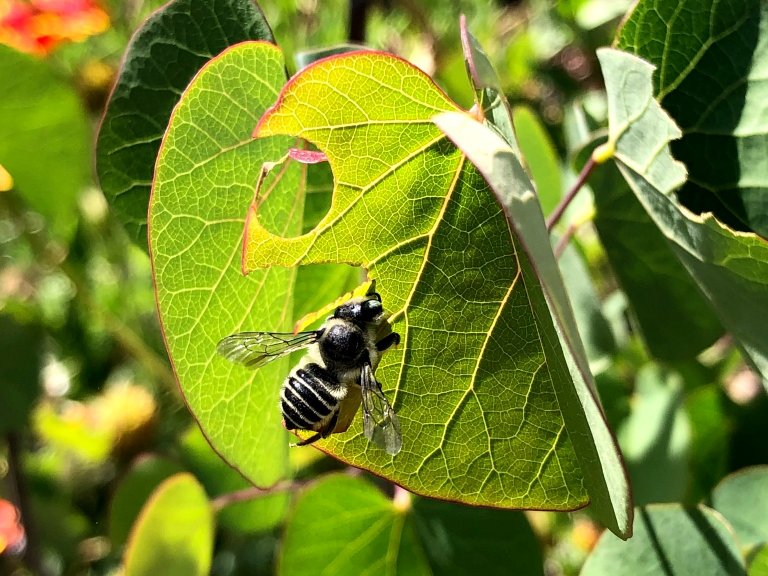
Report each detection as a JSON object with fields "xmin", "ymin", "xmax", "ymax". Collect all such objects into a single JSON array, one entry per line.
[{"xmin": 0, "ymin": 45, "xmax": 91, "ymax": 240}]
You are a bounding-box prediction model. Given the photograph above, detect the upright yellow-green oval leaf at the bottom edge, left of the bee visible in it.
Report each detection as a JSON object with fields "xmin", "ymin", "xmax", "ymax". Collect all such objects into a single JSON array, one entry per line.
[{"xmin": 123, "ymin": 473, "xmax": 214, "ymax": 576}]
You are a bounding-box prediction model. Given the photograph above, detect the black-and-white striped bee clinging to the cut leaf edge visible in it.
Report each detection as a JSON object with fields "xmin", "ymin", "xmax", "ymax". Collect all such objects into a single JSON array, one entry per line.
[{"xmin": 217, "ymin": 284, "xmax": 403, "ymax": 456}]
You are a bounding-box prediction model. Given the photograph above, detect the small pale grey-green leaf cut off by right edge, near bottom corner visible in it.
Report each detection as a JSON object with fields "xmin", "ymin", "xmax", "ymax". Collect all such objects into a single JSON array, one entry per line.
[{"xmin": 712, "ymin": 466, "xmax": 768, "ymax": 549}]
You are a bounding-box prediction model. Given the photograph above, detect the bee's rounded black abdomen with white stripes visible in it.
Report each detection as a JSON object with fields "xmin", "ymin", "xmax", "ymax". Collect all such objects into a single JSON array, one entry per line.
[{"xmin": 280, "ymin": 363, "xmax": 338, "ymax": 430}]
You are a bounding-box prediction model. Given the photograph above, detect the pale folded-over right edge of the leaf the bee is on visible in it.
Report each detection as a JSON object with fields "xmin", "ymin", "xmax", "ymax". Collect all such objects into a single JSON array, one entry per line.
[{"xmin": 435, "ymin": 113, "xmax": 632, "ymax": 538}]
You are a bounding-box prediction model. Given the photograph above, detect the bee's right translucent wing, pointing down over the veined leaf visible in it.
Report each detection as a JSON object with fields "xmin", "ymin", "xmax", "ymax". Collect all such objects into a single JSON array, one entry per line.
[{"xmin": 360, "ymin": 363, "xmax": 403, "ymax": 456}]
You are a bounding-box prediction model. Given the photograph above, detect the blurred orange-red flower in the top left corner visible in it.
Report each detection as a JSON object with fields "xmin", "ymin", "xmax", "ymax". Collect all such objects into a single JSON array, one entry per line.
[{"xmin": 0, "ymin": 0, "xmax": 109, "ymax": 56}]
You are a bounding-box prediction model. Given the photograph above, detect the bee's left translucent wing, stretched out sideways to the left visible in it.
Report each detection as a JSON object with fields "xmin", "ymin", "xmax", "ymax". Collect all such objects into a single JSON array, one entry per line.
[{"xmin": 216, "ymin": 331, "xmax": 318, "ymax": 368}]
